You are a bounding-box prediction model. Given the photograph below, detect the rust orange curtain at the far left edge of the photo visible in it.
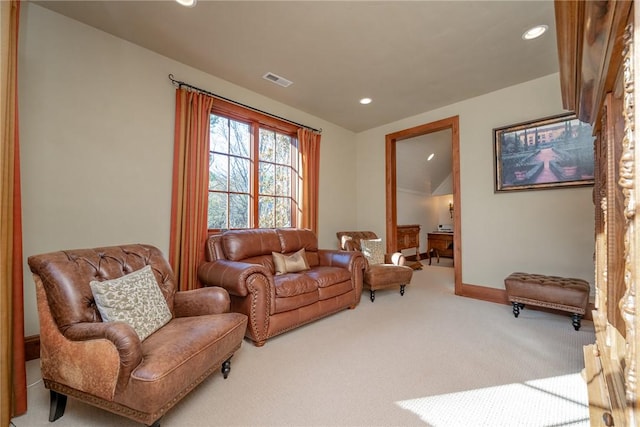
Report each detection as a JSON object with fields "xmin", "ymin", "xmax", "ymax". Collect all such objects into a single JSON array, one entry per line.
[{"xmin": 0, "ymin": 1, "xmax": 27, "ymax": 426}]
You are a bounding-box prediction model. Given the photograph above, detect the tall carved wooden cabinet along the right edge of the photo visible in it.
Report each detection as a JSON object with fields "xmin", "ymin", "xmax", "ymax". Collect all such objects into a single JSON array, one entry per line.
[{"xmin": 555, "ymin": 0, "xmax": 640, "ymax": 426}]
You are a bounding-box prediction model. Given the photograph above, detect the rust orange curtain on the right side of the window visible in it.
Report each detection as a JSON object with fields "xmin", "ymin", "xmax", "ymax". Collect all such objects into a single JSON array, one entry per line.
[{"xmin": 298, "ymin": 128, "xmax": 321, "ymax": 234}]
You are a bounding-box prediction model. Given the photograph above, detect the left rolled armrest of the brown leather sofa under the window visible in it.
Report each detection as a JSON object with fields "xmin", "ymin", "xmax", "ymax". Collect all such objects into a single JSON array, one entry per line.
[{"xmin": 198, "ymin": 259, "xmax": 273, "ymax": 297}]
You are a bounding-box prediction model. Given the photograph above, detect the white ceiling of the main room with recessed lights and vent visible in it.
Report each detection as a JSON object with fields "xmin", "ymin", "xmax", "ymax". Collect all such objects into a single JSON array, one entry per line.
[{"xmin": 35, "ymin": 0, "xmax": 558, "ymax": 132}]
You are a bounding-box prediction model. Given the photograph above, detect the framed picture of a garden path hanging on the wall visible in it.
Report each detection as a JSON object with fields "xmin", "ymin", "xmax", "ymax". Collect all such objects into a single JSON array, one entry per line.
[{"xmin": 493, "ymin": 114, "xmax": 594, "ymax": 192}]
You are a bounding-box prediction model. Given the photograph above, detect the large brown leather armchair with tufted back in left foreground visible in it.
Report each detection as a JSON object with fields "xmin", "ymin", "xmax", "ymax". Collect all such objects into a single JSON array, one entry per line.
[{"xmin": 28, "ymin": 244, "xmax": 247, "ymax": 426}]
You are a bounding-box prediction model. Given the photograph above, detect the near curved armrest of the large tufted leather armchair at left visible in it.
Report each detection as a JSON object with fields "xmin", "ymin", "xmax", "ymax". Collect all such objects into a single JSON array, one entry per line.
[{"xmin": 63, "ymin": 322, "xmax": 142, "ymax": 390}]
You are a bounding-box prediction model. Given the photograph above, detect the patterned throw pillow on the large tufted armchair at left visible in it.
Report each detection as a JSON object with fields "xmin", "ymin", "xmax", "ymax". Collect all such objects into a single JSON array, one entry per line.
[{"xmin": 89, "ymin": 265, "xmax": 171, "ymax": 341}]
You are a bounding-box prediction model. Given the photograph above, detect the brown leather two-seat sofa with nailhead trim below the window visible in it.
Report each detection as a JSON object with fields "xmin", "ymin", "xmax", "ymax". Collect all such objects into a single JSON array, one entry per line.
[{"xmin": 198, "ymin": 228, "xmax": 365, "ymax": 346}]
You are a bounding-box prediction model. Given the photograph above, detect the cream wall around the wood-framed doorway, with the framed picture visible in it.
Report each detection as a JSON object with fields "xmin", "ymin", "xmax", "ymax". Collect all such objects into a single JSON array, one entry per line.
[{"xmin": 356, "ymin": 74, "xmax": 594, "ymax": 288}]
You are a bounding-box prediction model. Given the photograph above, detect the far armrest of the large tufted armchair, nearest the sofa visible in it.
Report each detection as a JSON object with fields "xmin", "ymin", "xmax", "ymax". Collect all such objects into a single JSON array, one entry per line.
[{"xmin": 173, "ymin": 286, "xmax": 231, "ymax": 317}]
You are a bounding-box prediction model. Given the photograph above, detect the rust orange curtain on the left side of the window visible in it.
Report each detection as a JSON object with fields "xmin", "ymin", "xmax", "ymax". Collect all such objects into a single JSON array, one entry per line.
[{"xmin": 169, "ymin": 88, "xmax": 213, "ymax": 290}]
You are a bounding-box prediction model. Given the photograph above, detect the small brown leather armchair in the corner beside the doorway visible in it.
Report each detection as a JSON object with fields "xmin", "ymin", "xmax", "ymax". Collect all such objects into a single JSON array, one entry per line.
[{"xmin": 336, "ymin": 231, "xmax": 413, "ymax": 302}]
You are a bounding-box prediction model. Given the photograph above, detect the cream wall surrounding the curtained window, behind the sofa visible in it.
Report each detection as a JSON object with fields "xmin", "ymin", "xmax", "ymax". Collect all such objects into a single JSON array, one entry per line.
[{"xmin": 19, "ymin": 2, "xmax": 356, "ymax": 336}]
